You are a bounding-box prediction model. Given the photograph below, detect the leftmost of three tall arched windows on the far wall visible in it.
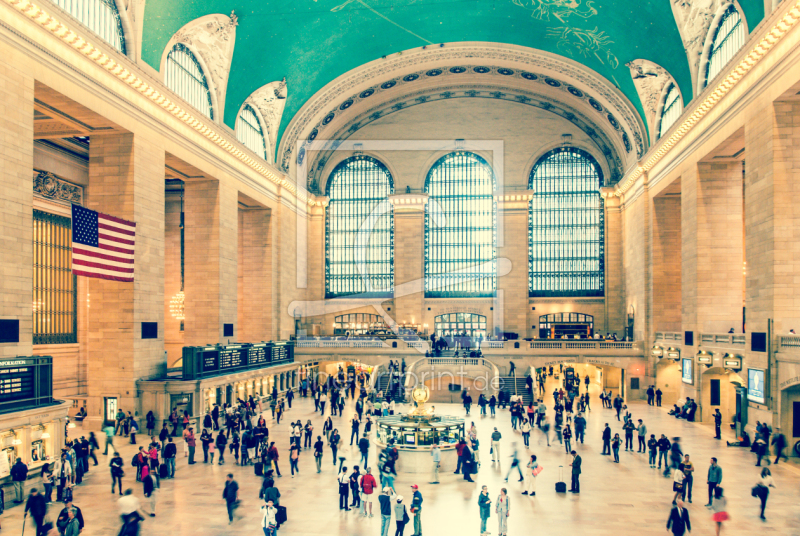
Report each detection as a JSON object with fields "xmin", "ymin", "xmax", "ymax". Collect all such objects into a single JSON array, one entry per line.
[{"xmin": 325, "ymin": 156, "xmax": 394, "ymax": 298}]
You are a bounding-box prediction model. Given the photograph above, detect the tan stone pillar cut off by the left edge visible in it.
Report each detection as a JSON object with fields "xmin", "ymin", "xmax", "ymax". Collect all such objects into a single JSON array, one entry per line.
[{"xmin": 0, "ymin": 63, "xmax": 33, "ymax": 357}]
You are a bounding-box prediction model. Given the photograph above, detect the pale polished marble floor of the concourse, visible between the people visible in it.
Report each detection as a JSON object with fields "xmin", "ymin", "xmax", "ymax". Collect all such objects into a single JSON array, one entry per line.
[{"xmin": 2, "ymin": 374, "xmax": 800, "ymax": 536}]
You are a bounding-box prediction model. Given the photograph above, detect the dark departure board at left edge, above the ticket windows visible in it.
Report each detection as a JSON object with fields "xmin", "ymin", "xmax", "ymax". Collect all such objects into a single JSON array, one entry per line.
[{"xmin": 0, "ymin": 356, "xmax": 53, "ymax": 413}]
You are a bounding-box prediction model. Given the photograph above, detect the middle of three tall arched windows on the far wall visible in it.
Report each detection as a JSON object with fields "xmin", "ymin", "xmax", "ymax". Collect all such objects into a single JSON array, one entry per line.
[{"xmin": 425, "ymin": 152, "xmax": 497, "ymax": 298}]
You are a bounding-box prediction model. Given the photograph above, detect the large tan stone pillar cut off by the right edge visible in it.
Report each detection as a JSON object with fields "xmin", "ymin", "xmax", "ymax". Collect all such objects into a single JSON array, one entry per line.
[{"xmin": 744, "ymin": 102, "xmax": 800, "ymax": 426}]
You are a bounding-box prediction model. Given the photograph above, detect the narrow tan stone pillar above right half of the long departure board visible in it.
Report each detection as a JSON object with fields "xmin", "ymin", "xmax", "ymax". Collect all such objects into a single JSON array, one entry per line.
[{"xmin": 237, "ymin": 209, "xmax": 273, "ymax": 342}]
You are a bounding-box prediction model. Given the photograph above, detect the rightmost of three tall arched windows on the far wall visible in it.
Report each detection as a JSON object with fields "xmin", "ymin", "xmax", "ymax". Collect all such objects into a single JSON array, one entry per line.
[{"xmin": 528, "ymin": 147, "xmax": 605, "ymax": 297}]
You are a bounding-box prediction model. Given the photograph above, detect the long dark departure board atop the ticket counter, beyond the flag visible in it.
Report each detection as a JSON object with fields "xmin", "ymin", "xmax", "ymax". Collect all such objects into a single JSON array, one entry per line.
[{"xmin": 183, "ymin": 341, "xmax": 294, "ymax": 380}]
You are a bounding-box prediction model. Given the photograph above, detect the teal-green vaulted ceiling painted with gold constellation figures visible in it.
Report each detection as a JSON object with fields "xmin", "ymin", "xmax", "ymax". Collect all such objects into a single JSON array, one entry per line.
[{"xmin": 142, "ymin": 0, "xmax": 764, "ymax": 147}]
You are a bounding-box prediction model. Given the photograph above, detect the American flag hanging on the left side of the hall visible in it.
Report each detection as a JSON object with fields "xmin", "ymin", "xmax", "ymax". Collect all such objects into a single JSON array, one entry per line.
[{"xmin": 72, "ymin": 205, "xmax": 136, "ymax": 281}]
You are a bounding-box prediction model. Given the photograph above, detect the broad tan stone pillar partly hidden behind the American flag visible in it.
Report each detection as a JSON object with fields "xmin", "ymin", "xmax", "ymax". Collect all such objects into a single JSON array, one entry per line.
[{"xmin": 86, "ymin": 133, "xmax": 166, "ymax": 427}]
